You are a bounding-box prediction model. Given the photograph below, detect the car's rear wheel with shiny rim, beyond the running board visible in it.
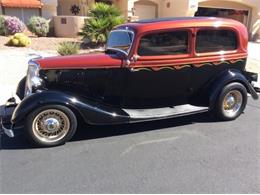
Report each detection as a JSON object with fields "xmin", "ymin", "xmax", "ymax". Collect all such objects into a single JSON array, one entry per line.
[{"xmin": 215, "ymin": 83, "xmax": 247, "ymax": 120}]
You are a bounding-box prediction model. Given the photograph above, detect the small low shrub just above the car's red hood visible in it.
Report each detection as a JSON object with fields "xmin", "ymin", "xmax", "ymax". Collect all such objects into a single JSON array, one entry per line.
[{"xmin": 57, "ymin": 42, "xmax": 80, "ymax": 56}]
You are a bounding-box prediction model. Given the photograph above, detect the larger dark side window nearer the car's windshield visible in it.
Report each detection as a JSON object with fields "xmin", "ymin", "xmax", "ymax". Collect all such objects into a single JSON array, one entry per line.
[{"xmin": 138, "ymin": 31, "xmax": 189, "ymax": 56}]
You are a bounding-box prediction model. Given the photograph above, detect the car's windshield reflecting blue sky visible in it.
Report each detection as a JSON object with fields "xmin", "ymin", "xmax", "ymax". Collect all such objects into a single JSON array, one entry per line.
[{"xmin": 107, "ymin": 30, "xmax": 134, "ymax": 54}]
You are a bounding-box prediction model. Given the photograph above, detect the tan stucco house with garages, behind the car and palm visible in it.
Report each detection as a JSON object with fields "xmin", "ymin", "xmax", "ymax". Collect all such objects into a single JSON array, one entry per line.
[{"xmin": 57, "ymin": 0, "xmax": 260, "ymax": 39}]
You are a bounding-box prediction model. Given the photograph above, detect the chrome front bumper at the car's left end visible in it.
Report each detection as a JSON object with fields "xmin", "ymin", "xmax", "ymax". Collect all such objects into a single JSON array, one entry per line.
[{"xmin": 0, "ymin": 98, "xmax": 17, "ymax": 137}]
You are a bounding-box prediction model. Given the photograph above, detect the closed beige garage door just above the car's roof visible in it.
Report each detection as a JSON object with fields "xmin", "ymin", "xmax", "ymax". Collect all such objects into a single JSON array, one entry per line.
[{"xmin": 135, "ymin": 3, "xmax": 156, "ymax": 20}]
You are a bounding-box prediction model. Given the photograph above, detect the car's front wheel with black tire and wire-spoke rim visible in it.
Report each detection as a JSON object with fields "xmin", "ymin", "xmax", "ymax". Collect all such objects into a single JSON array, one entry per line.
[{"xmin": 25, "ymin": 105, "xmax": 77, "ymax": 147}]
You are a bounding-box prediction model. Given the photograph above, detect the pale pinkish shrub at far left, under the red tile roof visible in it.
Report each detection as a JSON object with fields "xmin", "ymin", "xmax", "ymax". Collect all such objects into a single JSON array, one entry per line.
[{"xmin": 5, "ymin": 16, "xmax": 25, "ymax": 35}]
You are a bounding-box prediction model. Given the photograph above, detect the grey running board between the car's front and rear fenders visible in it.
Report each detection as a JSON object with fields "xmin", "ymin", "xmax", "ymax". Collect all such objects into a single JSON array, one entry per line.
[{"xmin": 123, "ymin": 104, "xmax": 209, "ymax": 121}]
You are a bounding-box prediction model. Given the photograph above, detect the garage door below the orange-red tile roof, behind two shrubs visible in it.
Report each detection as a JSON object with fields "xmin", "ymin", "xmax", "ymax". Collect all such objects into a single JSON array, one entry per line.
[{"xmin": 5, "ymin": 8, "xmax": 40, "ymax": 23}]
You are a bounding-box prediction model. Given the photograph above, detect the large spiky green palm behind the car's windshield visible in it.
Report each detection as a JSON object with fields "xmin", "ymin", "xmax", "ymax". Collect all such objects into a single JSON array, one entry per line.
[{"xmin": 80, "ymin": 3, "xmax": 125, "ymax": 44}]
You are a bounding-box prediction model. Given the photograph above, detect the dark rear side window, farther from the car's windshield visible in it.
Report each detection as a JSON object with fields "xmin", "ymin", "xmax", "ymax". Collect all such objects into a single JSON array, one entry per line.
[{"xmin": 196, "ymin": 30, "xmax": 237, "ymax": 53}]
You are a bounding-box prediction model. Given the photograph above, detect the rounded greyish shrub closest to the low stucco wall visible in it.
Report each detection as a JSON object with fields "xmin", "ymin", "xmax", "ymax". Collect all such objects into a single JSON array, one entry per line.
[{"xmin": 27, "ymin": 16, "xmax": 50, "ymax": 37}]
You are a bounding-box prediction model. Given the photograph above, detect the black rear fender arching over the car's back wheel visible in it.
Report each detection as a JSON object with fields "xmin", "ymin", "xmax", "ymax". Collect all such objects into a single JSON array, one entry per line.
[{"xmin": 209, "ymin": 70, "xmax": 258, "ymax": 108}]
